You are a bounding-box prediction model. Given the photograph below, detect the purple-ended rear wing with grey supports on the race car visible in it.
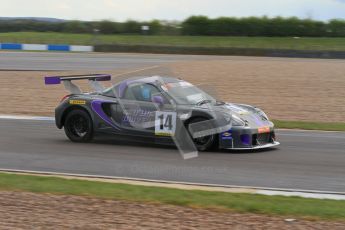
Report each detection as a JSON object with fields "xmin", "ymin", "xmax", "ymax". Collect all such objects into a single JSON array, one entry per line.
[{"xmin": 44, "ymin": 74, "xmax": 111, "ymax": 94}]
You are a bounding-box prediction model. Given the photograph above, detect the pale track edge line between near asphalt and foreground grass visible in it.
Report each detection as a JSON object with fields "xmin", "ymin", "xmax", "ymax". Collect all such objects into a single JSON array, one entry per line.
[{"xmin": 0, "ymin": 168, "xmax": 345, "ymax": 200}]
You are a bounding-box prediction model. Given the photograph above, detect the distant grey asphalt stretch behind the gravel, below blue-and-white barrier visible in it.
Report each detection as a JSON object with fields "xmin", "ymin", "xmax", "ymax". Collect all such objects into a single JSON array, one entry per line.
[{"xmin": 0, "ymin": 51, "xmax": 220, "ymax": 71}]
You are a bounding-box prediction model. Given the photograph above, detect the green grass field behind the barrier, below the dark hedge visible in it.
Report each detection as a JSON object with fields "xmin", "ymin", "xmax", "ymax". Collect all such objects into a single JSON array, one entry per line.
[{"xmin": 0, "ymin": 32, "xmax": 345, "ymax": 51}]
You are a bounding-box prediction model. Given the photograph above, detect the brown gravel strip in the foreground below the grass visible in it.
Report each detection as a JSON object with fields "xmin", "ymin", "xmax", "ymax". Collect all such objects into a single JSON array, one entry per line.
[{"xmin": 0, "ymin": 191, "xmax": 345, "ymax": 230}]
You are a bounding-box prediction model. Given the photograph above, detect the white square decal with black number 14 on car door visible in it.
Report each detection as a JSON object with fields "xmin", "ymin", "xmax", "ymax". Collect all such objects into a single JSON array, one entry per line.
[{"xmin": 155, "ymin": 111, "xmax": 176, "ymax": 136}]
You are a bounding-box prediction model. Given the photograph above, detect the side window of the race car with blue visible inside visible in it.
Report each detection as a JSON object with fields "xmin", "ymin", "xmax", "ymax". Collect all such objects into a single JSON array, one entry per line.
[{"xmin": 123, "ymin": 83, "xmax": 160, "ymax": 102}]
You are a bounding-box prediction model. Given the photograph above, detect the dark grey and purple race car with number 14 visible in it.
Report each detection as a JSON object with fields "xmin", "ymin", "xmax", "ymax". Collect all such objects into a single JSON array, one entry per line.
[{"xmin": 45, "ymin": 74, "xmax": 279, "ymax": 151}]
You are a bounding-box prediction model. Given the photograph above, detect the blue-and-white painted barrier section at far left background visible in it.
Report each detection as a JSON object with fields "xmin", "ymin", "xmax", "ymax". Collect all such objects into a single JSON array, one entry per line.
[{"xmin": 0, "ymin": 43, "xmax": 93, "ymax": 52}]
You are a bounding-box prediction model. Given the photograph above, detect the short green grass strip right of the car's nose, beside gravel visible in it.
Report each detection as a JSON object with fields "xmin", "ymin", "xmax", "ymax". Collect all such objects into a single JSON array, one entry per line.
[{"xmin": 273, "ymin": 120, "xmax": 345, "ymax": 131}]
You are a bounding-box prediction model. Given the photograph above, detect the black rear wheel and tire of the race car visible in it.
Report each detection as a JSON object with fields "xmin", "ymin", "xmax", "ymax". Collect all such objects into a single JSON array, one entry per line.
[{"xmin": 64, "ymin": 109, "xmax": 93, "ymax": 142}]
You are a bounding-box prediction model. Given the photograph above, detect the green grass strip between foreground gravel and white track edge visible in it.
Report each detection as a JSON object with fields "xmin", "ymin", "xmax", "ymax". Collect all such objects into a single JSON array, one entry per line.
[{"xmin": 0, "ymin": 173, "xmax": 345, "ymax": 220}]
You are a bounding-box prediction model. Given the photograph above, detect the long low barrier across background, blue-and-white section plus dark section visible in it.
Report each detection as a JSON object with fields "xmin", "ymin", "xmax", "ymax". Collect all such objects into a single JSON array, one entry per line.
[{"xmin": 0, "ymin": 43, "xmax": 345, "ymax": 59}]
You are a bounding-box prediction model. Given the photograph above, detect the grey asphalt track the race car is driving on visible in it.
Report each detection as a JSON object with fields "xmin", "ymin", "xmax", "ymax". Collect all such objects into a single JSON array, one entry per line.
[{"xmin": 0, "ymin": 119, "xmax": 345, "ymax": 192}]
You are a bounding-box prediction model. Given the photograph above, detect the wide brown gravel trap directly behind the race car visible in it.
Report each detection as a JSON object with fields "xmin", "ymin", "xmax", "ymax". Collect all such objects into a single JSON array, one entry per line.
[{"xmin": 0, "ymin": 57, "xmax": 345, "ymax": 122}]
